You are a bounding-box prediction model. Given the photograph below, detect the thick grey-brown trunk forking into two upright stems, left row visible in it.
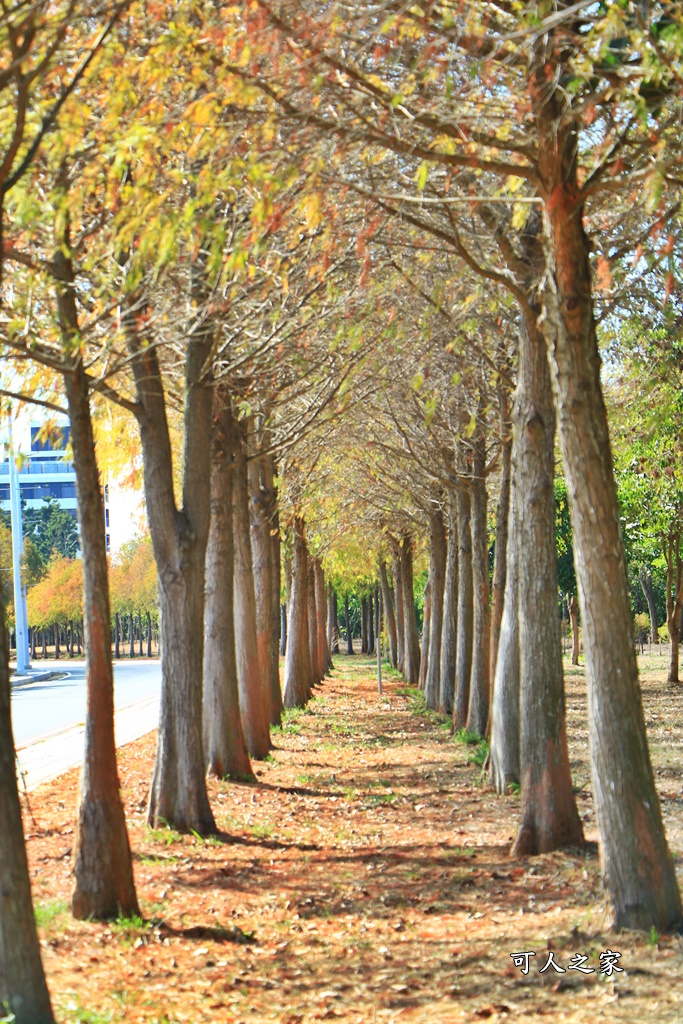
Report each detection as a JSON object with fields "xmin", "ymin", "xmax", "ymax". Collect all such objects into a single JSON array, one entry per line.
[{"xmin": 124, "ymin": 274, "xmax": 216, "ymax": 835}]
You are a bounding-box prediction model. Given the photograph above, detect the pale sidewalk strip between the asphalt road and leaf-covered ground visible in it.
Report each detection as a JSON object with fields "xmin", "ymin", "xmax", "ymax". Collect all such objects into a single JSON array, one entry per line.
[{"xmin": 16, "ymin": 696, "xmax": 159, "ymax": 791}]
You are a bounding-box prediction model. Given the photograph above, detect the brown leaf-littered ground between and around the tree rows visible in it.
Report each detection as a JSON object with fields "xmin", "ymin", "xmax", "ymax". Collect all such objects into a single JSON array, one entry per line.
[{"xmin": 21, "ymin": 657, "xmax": 683, "ymax": 1024}]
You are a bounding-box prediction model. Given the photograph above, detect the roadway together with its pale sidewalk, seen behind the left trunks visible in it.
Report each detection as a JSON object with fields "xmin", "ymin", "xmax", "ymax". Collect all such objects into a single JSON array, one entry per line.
[{"xmin": 11, "ymin": 660, "xmax": 161, "ymax": 790}]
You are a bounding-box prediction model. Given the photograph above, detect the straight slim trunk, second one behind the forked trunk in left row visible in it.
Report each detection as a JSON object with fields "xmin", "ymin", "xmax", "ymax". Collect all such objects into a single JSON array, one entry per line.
[{"xmin": 231, "ymin": 416, "xmax": 270, "ymax": 759}]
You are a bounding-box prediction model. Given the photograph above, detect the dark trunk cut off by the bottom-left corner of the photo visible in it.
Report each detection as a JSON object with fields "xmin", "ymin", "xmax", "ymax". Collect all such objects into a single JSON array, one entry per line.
[{"xmin": 0, "ymin": 598, "xmax": 55, "ymax": 1024}]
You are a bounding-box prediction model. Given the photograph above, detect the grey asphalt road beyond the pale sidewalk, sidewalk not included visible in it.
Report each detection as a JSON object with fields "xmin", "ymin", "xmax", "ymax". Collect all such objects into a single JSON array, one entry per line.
[{"xmin": 11, "ymin": 658, "xmax": 161, "ymax": 746}]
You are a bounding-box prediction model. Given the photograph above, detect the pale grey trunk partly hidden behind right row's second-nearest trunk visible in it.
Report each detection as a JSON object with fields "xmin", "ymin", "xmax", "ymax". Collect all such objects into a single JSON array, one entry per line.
[{"xmin": 489, "ymin": 466, "xmax": 521, "ymax": 795}]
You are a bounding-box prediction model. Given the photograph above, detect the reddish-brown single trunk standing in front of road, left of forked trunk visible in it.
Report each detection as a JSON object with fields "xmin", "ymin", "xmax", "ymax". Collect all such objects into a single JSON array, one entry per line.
[{"xmin": 52, "ymin": 248, "xmax": 139, "ymax": 920}]
